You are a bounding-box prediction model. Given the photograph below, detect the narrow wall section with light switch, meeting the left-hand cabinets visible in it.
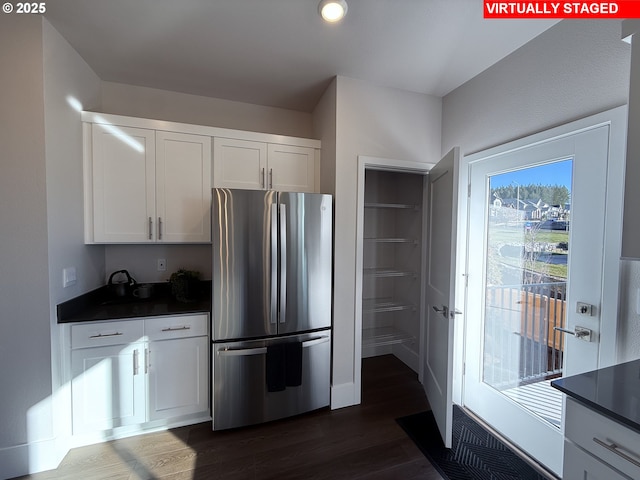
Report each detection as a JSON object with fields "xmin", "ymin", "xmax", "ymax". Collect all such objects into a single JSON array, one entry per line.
[{"xmin": 42, "ymin": 20, "xmax": 104, "ymax": 470}]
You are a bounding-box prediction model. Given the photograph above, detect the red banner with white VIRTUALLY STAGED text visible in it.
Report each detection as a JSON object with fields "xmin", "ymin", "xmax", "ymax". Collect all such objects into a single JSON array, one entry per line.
[{"xmin": 484, "ymin": 0, "xmax": 640, "ymax": 19}]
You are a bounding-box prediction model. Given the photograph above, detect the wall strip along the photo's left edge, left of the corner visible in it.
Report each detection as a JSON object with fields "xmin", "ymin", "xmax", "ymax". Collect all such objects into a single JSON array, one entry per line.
[{"xmin": 0, "ymin": 15, "xmax": 53, "ymax": 478}]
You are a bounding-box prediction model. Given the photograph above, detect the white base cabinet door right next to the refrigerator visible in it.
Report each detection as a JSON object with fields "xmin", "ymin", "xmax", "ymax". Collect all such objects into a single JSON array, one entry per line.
[{"xmin": 147, "ymin": 337, "xmax": 209, "ymax": 420}]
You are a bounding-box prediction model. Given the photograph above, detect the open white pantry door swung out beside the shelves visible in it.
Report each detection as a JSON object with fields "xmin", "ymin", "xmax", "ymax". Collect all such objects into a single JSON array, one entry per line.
[{"xmin": 423, "ymin": 148, "xmax": 459, "ymax": 448}]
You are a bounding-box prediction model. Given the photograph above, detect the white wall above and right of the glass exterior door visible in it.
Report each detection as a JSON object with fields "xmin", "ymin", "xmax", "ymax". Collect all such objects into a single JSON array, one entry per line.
[{"xmin": 442, "ymin": 20, "xmax": 640, "ymax": 364}]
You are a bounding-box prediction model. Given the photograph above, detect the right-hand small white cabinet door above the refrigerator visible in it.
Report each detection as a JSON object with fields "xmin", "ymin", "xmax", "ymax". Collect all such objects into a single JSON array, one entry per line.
[{"xmin": 267, "ymin": 143, "xmax": 315, "ymax": 192}]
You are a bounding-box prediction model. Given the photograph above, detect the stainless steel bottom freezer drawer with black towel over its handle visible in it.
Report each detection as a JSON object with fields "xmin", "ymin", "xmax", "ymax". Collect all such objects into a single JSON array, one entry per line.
[{"xmin": 212, "ymin": 330, "xmax": 331, "ymax": 430}]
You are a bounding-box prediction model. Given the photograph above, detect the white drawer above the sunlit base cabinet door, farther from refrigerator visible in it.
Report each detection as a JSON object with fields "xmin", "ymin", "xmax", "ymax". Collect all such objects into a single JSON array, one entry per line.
[{"xmin": 71, "ymin": 320, "xmax": 144, "ymax": 349}]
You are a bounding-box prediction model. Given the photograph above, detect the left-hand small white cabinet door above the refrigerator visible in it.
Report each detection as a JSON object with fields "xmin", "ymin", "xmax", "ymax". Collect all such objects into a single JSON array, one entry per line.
[{"xmin": 213, "ymin": 138, "xmax": 267, "ymax": 190}]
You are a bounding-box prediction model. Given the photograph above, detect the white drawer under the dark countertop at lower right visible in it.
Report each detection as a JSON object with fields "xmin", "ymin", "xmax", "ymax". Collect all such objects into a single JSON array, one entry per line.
[{"xmin": 565, "ymin": 398, "xmax": 640, "ymax": 478}]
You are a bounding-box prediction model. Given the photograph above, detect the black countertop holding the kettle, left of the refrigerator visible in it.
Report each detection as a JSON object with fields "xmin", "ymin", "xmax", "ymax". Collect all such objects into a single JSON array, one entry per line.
[{"xmin": 57, "ymin": 282, "xmax": 211, "ymax": 323}]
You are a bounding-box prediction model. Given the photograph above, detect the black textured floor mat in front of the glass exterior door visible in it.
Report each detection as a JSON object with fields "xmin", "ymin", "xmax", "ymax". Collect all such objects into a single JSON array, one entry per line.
[{"xmin": 396, "ymin": 406, "xmax": 548, "ymax": 480}]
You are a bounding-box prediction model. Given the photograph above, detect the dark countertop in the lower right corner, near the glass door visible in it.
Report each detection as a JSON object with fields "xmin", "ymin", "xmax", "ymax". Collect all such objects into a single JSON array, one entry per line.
[{"xmin": 551, "ymin": 360, "xmax": 640, "ymax": 433}]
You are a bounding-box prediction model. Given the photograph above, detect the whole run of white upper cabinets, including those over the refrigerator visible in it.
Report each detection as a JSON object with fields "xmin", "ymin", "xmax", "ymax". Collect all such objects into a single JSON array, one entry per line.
[{"xmin": 82, "ymin": 112, "xmax": 320, "ymax": 243}]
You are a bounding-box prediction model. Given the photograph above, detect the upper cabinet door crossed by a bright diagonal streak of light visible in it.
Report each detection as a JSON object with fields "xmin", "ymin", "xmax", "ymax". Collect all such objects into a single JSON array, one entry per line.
[{"xmin": 92, "ymin": 124, "xmax": 156, "ymax": 243}]
